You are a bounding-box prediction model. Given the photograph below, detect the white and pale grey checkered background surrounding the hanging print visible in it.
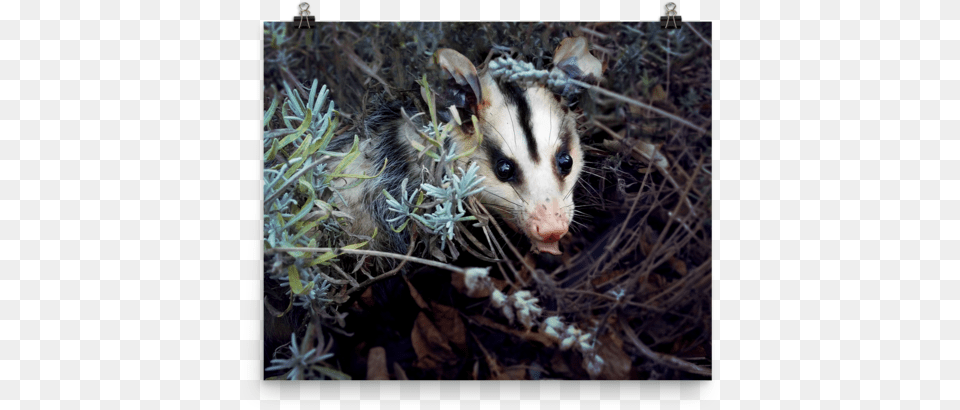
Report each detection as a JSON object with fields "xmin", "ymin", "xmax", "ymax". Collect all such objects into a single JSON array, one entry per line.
[{"xmin": 0, "ymin": 0, "xmax": 960, "ymax": 410}]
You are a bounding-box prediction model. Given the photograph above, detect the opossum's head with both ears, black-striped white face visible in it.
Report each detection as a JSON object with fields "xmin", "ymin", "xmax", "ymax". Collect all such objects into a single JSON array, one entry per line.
[{"xmin": 434, "ymin": 37, "xmax": 603, "ymax": 255}]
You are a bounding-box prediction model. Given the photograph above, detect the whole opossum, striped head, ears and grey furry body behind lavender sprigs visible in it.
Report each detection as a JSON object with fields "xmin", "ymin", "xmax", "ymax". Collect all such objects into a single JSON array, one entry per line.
[{"xmin": 332, "ymin": 37, "xmax": 601, "ymax": 255}]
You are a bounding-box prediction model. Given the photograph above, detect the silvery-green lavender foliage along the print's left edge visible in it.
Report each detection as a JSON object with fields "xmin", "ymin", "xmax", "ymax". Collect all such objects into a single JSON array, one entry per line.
[{"xmin": 263, "ymin": 80, "xmax": 360, "ymax": 324}]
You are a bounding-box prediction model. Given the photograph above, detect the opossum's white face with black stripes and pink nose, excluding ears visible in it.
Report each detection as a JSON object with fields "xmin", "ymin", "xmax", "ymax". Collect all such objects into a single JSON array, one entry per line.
[{"xmin": 475, "ymin": 75, "xmax": 583, "ymax": 255}]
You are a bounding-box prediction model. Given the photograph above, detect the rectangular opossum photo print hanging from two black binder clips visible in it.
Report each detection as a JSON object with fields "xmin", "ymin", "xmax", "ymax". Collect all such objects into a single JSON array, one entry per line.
[{"xmin": 263, "ymin": 21, "xmax": 712, "ymax": 380}]
